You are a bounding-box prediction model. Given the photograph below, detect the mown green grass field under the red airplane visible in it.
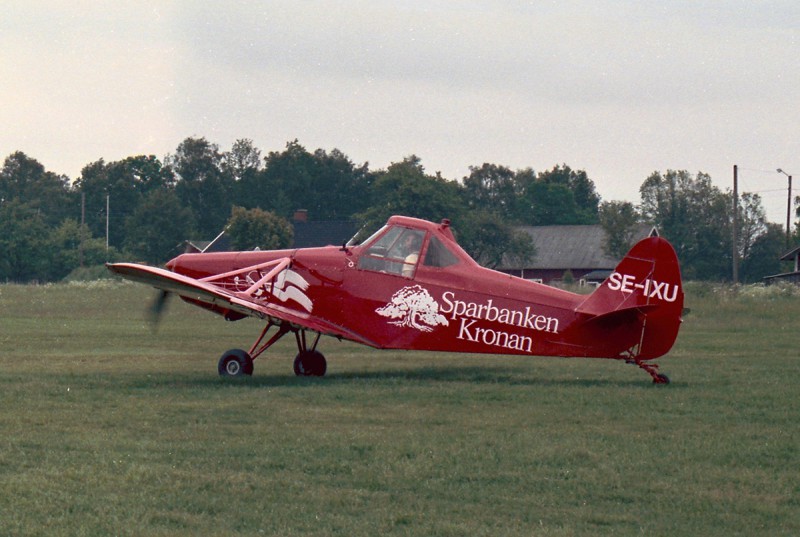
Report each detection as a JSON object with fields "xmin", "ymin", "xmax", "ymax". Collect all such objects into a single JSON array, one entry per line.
[{"xmin": 0, "ymin": 283, "xmax": 800, "ymax": 536}]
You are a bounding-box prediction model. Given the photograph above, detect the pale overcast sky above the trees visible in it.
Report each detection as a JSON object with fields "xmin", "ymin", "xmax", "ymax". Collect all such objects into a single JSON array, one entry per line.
[{"xmin": 0, "ymin": 0, "xmax": 800, "ymax": 223}]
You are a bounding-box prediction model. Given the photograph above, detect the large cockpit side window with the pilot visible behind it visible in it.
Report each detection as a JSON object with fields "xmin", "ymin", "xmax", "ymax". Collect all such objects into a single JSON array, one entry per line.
[{"xmin": 358, "ymin": 226, "xmax": 425, "ymax": 278}]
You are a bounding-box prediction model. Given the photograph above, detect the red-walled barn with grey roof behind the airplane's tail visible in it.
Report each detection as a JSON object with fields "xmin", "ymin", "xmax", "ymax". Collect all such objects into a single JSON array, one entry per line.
[{"xmin": 498, "ymin": 225, "xmax": 653, "ymax": 284}]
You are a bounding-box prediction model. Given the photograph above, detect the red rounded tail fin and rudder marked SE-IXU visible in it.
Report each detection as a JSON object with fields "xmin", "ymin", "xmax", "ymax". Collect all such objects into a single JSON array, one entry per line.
[{"xmin": 577, "ymin": 237, "xmax": 683, "ymax": 360}]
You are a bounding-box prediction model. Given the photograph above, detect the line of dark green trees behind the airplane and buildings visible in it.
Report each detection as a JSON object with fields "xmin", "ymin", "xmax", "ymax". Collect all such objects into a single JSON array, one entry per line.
[{"xmin": 0, "ymin": 137, "xmax": 785, "ymax": 282}]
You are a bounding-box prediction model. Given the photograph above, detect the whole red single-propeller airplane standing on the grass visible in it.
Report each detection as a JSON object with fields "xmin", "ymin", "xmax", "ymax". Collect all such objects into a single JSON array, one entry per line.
[{"xmin": 108, "ymin": 216, "xmax": 683, "ymax": 384}]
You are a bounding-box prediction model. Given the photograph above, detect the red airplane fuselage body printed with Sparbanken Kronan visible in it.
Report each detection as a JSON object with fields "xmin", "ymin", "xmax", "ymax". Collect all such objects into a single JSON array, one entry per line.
[{"xmin": 168, "ymin": 214, "xmax": 656, "ymax": 356}]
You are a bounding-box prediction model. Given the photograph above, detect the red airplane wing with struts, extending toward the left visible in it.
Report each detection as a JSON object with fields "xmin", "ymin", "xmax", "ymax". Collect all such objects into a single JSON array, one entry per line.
[{"xmin": 106, "ymin": 259, "xmax": 377, "ymax": 347}]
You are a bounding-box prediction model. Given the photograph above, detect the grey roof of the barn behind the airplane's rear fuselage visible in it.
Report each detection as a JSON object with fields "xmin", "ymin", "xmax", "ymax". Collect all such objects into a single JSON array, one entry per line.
[{"xmin": 500, "ymin": 225, "xmax": 652, "ymax": 270}]
